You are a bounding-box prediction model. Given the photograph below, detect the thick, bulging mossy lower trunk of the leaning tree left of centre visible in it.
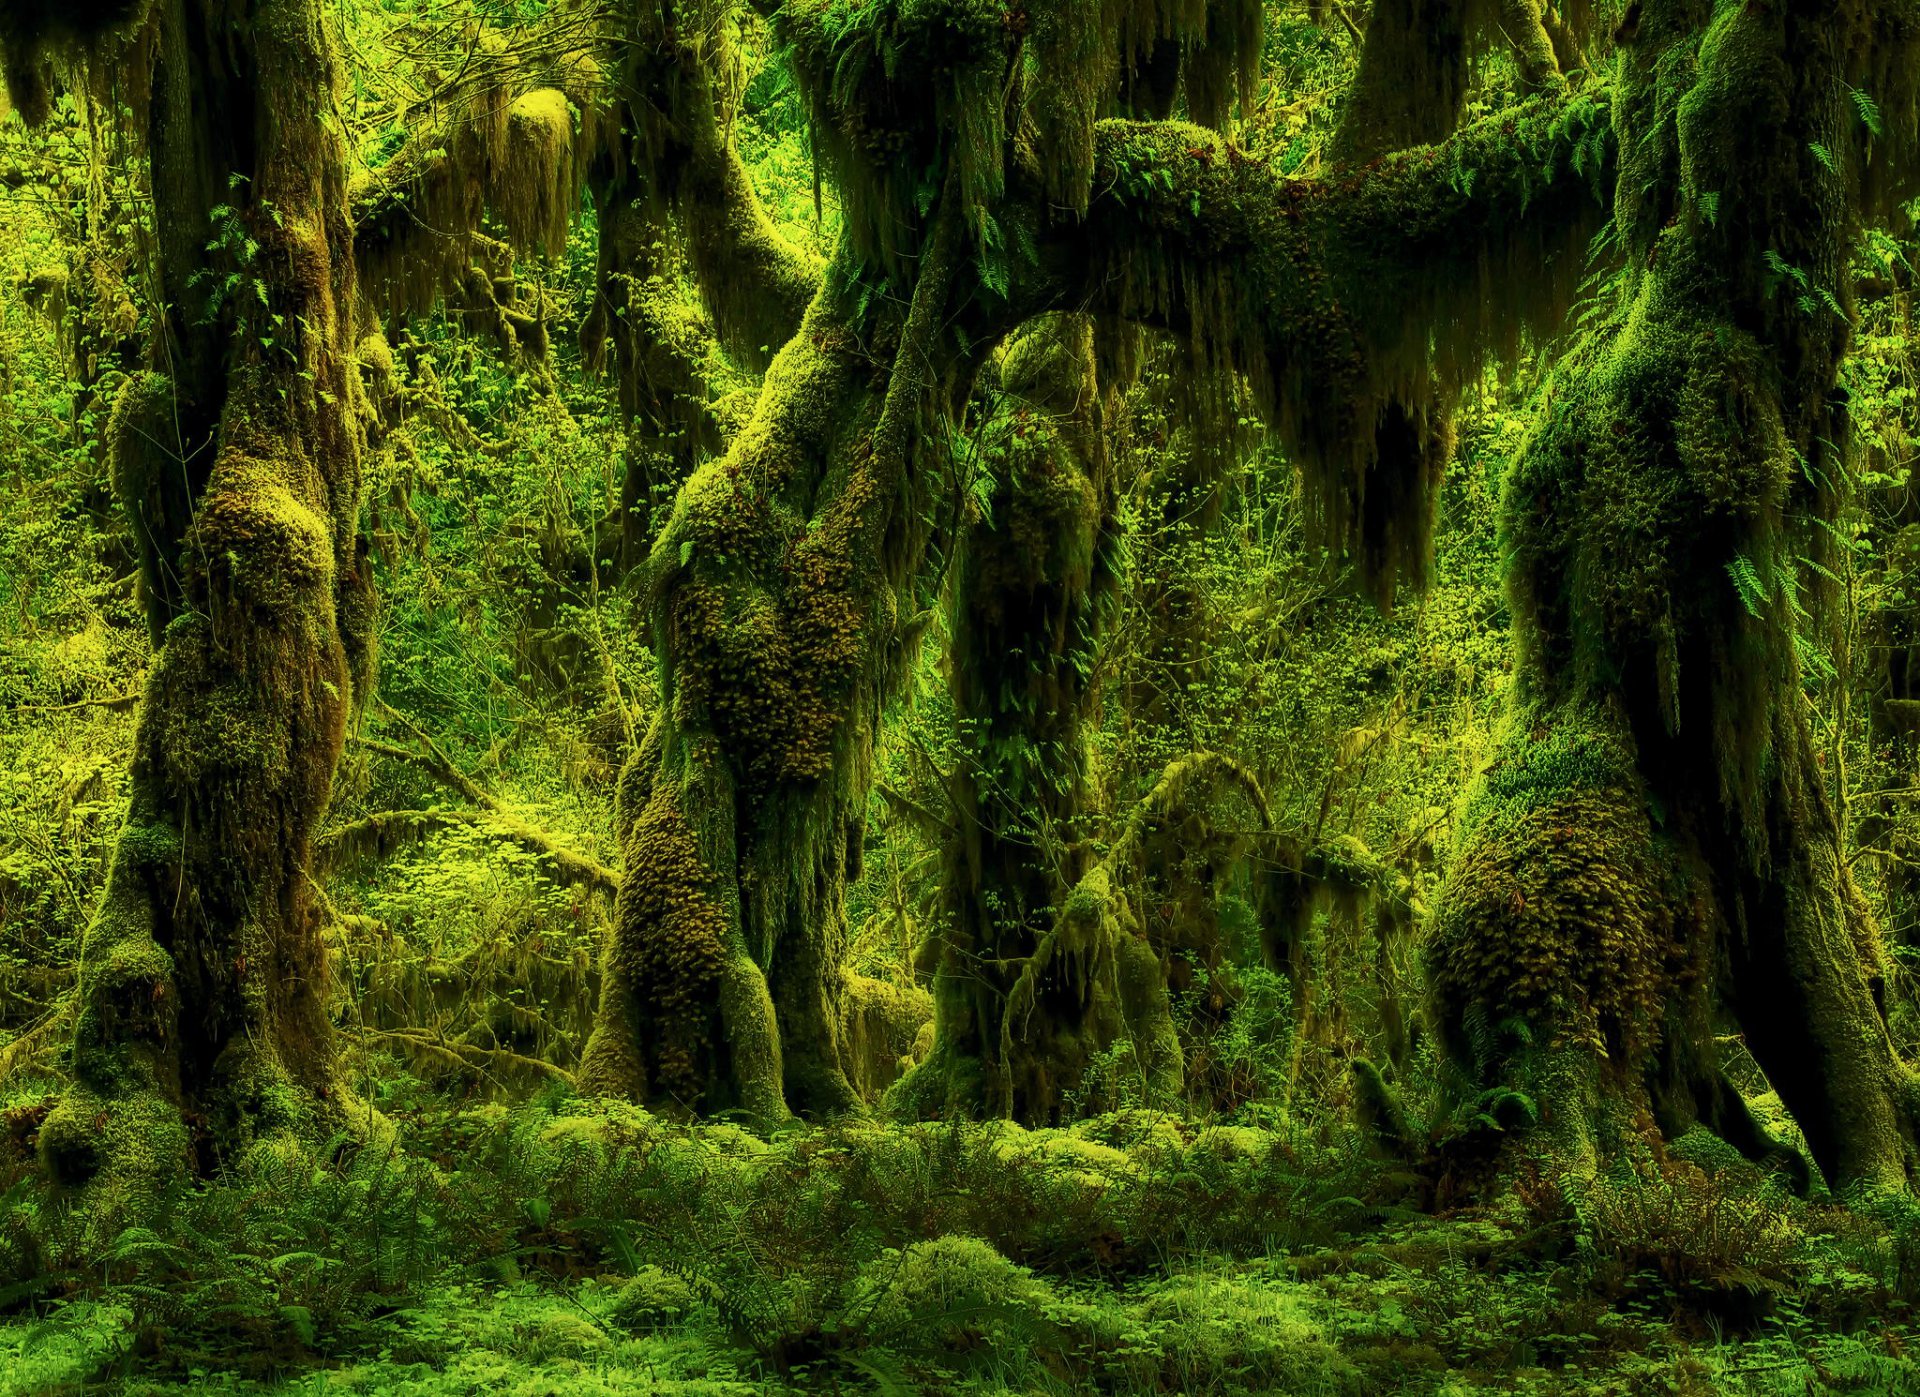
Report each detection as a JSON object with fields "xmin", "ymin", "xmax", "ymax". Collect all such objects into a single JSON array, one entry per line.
[{"xmin": 582, "ymin": 232, "xmax": 968, "ymax": 1119}]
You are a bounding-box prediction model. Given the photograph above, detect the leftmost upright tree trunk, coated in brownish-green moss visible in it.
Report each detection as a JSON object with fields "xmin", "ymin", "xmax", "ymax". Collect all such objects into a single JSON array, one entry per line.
[{"xmin": 9, "ymin": 0, "xmax": 371, "ymax": 1201}]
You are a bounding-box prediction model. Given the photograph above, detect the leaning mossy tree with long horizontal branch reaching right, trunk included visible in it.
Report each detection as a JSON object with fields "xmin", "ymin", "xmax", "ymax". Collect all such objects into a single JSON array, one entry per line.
[{"xmin": 588, "ymin": 4, "xmax": 1607, "ymax": 1117}]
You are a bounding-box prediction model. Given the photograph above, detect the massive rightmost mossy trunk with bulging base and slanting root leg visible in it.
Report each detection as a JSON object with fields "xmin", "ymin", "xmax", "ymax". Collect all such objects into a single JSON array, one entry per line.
[{"xmin": 1428, "ymin": 0, "xmax": 1916, "ymax": 1188}]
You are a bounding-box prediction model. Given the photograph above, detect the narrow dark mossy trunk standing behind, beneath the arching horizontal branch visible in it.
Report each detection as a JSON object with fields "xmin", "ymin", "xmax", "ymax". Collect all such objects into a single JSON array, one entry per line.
[{"xmin": 889, "ymin": 317, "xmax": 1181, "ymax": 1123}]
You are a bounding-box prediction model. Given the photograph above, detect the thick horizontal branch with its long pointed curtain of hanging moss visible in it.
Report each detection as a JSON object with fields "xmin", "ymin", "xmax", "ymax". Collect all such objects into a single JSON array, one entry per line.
[{"xmin": 1073, "ymin": 87, "xmax": 1611, "ymax": 599}]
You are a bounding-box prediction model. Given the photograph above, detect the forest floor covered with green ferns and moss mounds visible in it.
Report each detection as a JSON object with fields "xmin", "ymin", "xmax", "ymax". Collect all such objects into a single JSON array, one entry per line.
[{"xmin": 0, "ymin": 1101, "xmax": 1920, "ymax": 1397}]
